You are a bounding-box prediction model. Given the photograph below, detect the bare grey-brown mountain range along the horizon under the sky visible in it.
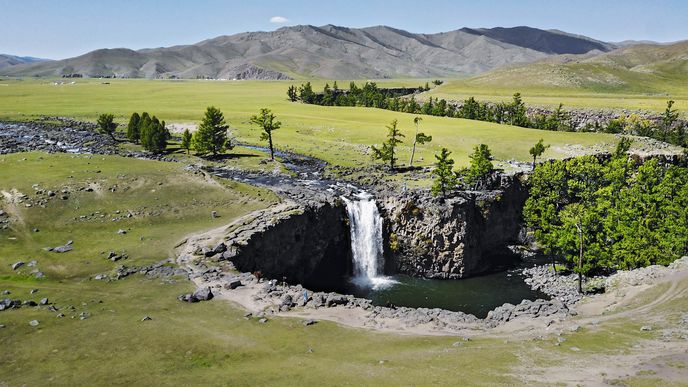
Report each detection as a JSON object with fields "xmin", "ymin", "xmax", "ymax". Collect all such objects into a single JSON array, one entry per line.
[{"xmin": 0, "ymin": 25, "xmax": 614, "ymax": 79}]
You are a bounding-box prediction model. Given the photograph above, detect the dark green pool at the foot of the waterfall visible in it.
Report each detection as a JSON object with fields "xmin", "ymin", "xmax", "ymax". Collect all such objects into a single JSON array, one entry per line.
[{"xmin": 346, "ymin": 269, "xmax": 548, "ymax": 318}]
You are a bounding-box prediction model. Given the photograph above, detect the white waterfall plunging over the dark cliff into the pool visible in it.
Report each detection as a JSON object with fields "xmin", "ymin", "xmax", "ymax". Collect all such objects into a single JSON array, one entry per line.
[{"xmin": 342, "ymin": 192, "xmax": 394, "ymax": 289}]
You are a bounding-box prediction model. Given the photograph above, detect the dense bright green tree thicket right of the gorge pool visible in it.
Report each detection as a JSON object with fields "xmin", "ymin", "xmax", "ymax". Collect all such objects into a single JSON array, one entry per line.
[{"xmin": 523, "ymin": 139, "xmax": 688, "ymax": 291}]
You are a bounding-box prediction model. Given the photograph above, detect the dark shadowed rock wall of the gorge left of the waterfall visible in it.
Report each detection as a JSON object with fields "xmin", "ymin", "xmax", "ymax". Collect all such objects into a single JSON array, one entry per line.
[{"xmin": 231, "ymin": 202, "xmax": 351, "ymax": 288}]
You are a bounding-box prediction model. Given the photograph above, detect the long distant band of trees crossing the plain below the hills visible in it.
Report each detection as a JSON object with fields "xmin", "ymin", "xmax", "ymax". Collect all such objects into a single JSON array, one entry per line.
[{"xmin": 287, "ymin": 81, "xmax": 688, "ymax": 147}]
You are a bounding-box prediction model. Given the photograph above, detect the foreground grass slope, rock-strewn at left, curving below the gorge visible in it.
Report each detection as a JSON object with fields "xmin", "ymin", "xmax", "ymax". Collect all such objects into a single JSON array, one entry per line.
[{"xmin": 0, "ymin": 153, "xmax": 688, "ymax": 386}]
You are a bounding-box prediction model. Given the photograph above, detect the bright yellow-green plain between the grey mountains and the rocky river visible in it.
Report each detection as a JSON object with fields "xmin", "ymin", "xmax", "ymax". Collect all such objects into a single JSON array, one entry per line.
[{"xmin": 0, "ymin": 79, "xmax": 615, "ymax": 166}]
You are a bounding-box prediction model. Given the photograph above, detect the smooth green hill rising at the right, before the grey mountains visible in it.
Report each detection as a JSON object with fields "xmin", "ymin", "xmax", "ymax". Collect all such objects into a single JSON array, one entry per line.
[{"xmin": 460, "ymin": 41, "xmax": 688, "ymax": 93}]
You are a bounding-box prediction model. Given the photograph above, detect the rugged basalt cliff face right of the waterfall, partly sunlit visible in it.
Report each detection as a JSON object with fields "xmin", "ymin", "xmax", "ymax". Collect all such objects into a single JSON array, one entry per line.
[{"xmin": 382, "ymin": 175, "xmax": 528, "ymax": 279}]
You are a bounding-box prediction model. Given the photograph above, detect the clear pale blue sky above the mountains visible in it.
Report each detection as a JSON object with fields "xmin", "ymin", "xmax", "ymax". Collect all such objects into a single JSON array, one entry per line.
[{"xmin": 0, "ymin": 0, "xmax": 688, "ymax": 59}]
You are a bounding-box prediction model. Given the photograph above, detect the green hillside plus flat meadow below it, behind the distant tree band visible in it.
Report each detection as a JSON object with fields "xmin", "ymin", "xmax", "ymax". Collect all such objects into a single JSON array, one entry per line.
[{"xmin": 428, "ymin": 42, "xmax": 688, "ymax": 113}]
